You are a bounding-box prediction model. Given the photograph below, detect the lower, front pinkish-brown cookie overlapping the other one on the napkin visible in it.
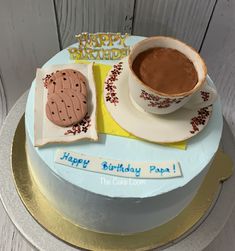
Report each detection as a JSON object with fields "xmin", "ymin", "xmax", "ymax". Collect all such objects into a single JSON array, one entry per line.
[{"xmin": 46, "ymin": 89, "xmax": 87, "ymax": 127}]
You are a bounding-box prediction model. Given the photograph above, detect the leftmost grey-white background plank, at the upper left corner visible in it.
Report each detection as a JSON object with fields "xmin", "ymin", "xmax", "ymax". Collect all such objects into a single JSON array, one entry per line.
[{"xmin": 0, "ymin": 0, "xmax": 59, "ymax": 108}]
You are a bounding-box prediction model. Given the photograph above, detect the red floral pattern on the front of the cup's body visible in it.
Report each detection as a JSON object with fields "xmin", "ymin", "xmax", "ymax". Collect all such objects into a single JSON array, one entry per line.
[{"xmin": 140, "ymin": 90, "xmax": 184, "ymax": 108}]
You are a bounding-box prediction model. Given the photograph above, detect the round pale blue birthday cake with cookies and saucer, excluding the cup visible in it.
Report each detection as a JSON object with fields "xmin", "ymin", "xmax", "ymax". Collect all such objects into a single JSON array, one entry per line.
[{"xmin": 25, "ymin": 36, "xmax": 223, "ymax": 234}]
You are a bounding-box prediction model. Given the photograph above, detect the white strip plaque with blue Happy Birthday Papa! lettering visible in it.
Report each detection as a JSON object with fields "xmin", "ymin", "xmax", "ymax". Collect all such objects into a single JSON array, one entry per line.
[{"xmin": 55, "ymin": 149, "xmax": 182, "ymax": 179}]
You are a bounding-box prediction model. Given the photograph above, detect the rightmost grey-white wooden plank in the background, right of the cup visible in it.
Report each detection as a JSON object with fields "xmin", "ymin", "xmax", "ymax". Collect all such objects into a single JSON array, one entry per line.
[{"xmin": 201, "ymin": 0, "xmax": 235, "ymax": 136}]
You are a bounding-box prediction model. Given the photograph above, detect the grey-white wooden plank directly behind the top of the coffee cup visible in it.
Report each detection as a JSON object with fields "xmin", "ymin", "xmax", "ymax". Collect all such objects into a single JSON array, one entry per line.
[{"xmin": 133, "ymin": 0, "xmax": 215, "ymax": 50}]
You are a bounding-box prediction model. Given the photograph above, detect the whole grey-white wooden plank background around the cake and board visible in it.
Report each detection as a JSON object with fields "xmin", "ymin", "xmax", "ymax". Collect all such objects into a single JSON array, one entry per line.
[{"xmin": 0, "ymin": 0, "xmax": 235, "ymax": 251}]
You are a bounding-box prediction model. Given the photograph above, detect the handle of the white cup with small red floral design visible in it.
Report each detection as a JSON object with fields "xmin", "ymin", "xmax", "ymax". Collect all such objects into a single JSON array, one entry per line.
[{"xmin": 184, "ymin": 82, "xmax": 218, "ymax": 110}]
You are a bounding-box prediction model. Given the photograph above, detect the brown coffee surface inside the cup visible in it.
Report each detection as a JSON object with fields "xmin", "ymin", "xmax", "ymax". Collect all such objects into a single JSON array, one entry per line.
[{"xmin": 132, "ymin": 47, "xmax": 198, "ymax": 94}]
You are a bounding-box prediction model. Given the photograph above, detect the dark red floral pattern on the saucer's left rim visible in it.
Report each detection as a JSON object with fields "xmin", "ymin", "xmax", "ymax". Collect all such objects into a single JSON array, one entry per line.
[{"xmin": 104, "ymin": 62, "xmax": 123, "ymax": 106}]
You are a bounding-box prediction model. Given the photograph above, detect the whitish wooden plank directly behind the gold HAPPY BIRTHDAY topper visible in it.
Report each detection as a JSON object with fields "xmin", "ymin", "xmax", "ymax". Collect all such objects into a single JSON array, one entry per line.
[{"xmin": 55, "ymin": 0, "xmax": 134, "ymax": 48}]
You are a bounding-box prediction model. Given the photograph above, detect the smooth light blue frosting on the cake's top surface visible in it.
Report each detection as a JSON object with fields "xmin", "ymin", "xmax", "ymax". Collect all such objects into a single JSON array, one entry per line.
[{"xmin": 25, "ymin": 36, "xmax": 223, "ymax": 198}]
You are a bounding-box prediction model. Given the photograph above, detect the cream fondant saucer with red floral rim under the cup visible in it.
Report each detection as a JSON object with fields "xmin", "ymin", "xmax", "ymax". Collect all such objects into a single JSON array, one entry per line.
[{"xmin": 103, "ymin": 58, "xmax": 213, "ymax": 143}]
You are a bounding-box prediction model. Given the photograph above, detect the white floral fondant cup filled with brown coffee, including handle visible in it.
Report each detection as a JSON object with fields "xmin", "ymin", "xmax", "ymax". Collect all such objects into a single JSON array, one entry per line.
[{"xmin": 128, "ymin": 36, "xmax": 217, "ymax": 114}]
